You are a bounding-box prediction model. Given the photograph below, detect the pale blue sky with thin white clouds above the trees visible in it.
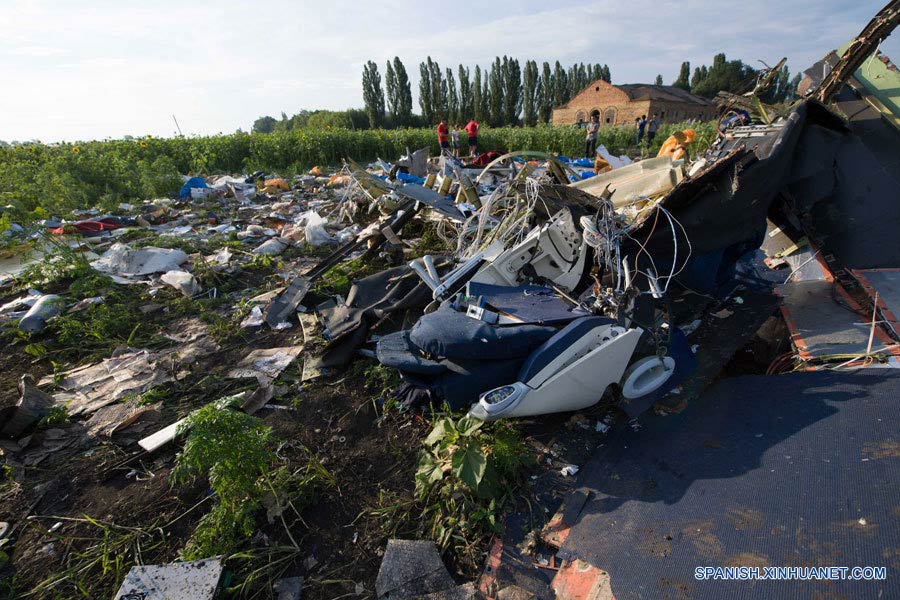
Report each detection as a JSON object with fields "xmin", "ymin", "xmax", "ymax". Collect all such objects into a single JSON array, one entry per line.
[{"xmin": 0, "ymin": 0, "xmax": 900, "ymax": 143}]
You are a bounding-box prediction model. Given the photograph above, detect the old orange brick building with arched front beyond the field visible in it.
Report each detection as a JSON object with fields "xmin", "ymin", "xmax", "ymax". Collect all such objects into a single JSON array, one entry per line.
[{"xmin": 551, "ymin": 79, "xmax": 718, "ymax": 125}]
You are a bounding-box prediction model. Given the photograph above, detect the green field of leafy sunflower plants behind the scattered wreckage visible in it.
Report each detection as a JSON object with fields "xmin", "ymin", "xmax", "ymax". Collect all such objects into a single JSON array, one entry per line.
[{"xmin": 0, "ymin": 123, "xmax": 715, "ymax": 220}]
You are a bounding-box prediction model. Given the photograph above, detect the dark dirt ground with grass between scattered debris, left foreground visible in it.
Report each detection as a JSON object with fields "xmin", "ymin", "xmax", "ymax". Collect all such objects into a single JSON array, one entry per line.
[{"xmin": 0, "ymin": 205, "xmax": 444, "ymax": 599}]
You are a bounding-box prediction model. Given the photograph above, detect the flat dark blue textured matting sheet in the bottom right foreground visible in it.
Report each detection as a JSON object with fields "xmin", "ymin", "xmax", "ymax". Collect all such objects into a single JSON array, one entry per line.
[{"xmin": 558, "ymin": 369, "xmax": 900, "ymax": 600}]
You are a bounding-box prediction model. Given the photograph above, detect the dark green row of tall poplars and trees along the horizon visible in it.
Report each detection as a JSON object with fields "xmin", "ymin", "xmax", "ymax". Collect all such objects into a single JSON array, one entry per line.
[{"xmin": 253, "ymin": 54, "xmax": 800, "ymax": 133}]
